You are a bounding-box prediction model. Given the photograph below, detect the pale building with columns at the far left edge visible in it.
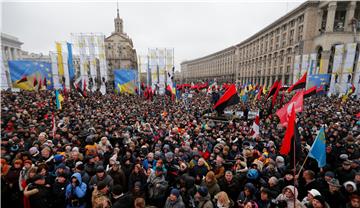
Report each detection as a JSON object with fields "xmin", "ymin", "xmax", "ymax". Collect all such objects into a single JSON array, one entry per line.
[{"xmin": 0, "ymin": 33, "xmax": 23, "ymax": 89}]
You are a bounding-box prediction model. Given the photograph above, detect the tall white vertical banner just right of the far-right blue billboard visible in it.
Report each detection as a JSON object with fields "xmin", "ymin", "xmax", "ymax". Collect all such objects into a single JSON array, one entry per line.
[{"xmin": 329, "ymin": 45, "xmax": 344, "ymax": 95}]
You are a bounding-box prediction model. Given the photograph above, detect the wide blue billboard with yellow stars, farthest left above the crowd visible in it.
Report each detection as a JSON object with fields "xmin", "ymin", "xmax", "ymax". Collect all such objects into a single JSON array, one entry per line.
[{"xmin": 8, "ymin": 60, "xmax": 53, "ymax": 91}]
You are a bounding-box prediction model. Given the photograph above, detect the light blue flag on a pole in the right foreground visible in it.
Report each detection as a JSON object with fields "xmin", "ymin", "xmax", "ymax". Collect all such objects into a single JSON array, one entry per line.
[{"xmin": 309, "ymin": 127, "xmax": 326, "ymax": 168}]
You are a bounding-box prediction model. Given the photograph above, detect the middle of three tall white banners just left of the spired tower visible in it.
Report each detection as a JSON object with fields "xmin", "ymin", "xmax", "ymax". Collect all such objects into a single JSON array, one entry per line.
[{"xmin": 87, "ymin": 35, "xmax": 97, "ymax": 92}]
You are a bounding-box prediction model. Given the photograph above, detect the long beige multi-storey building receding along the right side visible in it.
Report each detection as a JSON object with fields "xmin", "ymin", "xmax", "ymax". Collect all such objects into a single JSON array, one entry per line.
[{"xmin": 181, "ymin": 1, "xmax": 360, "ymax": 85}]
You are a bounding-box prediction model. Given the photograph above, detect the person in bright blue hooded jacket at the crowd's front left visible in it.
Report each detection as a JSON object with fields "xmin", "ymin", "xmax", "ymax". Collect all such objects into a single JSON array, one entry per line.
[{"xmin": 65, "ymin": 173, "xmax": 87, "ymax": 208}]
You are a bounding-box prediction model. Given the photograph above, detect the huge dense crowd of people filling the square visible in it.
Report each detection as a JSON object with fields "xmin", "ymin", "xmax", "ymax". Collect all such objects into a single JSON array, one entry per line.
[{"xmin": 1, "ymin": 87, "xmax": 360, "ymax": 208}]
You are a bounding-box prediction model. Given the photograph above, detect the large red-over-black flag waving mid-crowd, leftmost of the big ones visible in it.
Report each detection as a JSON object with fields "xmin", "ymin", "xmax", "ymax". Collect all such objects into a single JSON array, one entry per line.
[{"xmin": 213, "ymin": 84, "xmax": 240, "ymax": 113}]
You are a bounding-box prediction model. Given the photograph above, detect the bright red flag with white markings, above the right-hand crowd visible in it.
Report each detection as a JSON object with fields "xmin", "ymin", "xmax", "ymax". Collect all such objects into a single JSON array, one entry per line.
[{"xmin": 276, "ymin": 91, "xmax": 304, "ymax": 126}]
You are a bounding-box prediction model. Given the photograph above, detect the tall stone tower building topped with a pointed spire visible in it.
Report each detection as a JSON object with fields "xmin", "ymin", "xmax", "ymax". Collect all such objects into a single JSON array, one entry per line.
[{"xmin": 105, "ymin": 5, "xmax": 137, "ymax": 81}]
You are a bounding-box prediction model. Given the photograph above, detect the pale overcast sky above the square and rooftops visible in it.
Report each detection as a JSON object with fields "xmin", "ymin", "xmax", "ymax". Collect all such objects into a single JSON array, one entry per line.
[{"xmin": 1, "ymin": 1, "xmax": 303, "ymax": 70}]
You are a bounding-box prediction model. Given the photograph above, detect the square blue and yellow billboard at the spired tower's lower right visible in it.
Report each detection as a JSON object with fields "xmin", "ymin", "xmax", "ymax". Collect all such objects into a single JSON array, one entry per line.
[{"xmin": 114, "ymin": 69, "xmax": 137, "ymax": 94}]
